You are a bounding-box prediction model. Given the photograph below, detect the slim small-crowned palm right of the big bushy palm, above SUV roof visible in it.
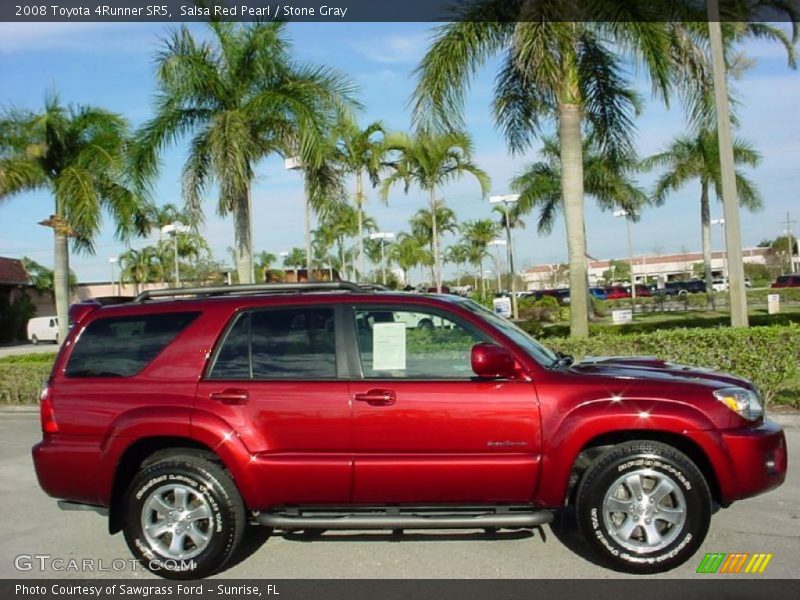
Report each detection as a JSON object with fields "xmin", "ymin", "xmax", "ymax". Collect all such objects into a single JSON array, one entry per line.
[{"xmin": 337, "ymin": 119, "xmax": 386, "ymax": 274}]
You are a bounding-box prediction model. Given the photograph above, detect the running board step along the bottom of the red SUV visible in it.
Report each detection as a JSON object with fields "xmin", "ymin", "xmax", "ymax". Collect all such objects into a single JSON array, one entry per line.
[{"xmin": 256, "ymin": 510, "xmax": 553, "ymax": 529}]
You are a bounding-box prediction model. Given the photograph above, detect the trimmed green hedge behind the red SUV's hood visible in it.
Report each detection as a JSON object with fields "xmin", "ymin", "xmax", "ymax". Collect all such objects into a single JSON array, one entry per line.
[{"xmin": 547, "ymin": 324, "xmax": 800, "ymax": 402}]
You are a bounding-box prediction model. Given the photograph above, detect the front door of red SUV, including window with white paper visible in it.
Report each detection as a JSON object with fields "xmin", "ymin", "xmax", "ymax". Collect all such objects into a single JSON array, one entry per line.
[{"xmin": 350, "ymin": 306, "xmax": 541, "ymax": 504}]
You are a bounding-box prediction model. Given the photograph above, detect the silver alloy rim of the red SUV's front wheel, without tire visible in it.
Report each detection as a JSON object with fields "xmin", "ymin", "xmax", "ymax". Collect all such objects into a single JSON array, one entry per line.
[{"xmin": 603, "ymin": 469, "xmax": 686, "ymax": 553}]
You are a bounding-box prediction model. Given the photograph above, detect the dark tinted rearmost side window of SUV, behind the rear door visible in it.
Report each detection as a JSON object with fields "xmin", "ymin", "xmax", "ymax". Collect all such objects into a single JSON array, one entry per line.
[{"xmin": 66, "ymin": 312, "xmax": 200, "ymax": 377}]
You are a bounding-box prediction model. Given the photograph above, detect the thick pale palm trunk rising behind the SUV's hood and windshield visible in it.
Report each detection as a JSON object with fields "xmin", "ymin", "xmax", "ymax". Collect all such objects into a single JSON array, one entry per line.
[{"xmin": 558, "ymin": 104, "xmax": 589, "ymax": 337}]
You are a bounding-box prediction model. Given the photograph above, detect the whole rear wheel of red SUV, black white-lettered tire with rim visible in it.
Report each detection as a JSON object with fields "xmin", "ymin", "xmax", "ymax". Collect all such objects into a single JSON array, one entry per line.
[{"xmin": 123, "ymin": 453, "xmax": 246, "ymax": 579}]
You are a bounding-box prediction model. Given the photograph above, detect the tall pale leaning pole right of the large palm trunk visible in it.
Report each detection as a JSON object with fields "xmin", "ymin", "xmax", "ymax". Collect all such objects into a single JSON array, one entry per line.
[{"xmin": 706, "ymin": 0, "xmax": 748, "ymax": 327}]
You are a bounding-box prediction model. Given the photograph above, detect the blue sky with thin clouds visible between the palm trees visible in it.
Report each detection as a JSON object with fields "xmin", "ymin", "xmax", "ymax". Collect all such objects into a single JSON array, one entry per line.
[{"xmin": 0, "ymin": 18, "xmax": 800, "ymax": 282}]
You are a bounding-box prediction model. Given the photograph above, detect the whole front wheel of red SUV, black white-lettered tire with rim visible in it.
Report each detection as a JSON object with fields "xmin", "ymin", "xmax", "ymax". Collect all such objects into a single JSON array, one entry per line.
[{"xmin": 576, "ymin": 441, "xmax": 712, "ymax": 574}]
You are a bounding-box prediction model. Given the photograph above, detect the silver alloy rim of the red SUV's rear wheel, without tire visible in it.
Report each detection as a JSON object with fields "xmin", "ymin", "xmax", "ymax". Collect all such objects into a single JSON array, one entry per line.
[{"xmin": 142, "ymin": 483, "xmax": 214, "ymax": 560}]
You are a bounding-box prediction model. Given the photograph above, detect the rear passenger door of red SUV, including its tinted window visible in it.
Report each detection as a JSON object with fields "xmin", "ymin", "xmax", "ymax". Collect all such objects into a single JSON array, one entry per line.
[{"xmin": 196, "ymin": 305, "xmax": 352, "ymax": 508}]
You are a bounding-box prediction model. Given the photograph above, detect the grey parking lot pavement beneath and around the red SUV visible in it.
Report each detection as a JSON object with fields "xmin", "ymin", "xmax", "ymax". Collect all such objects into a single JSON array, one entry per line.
[{"xmin": 0, "ymin": 413, "xmax": 800, "ymax": 579}]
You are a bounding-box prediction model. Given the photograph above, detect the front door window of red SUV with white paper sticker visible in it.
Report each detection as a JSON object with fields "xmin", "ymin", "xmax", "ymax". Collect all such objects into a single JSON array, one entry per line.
[{"xmin": 355, "ymin": 309, "xmax": 488, "ymax": 379}]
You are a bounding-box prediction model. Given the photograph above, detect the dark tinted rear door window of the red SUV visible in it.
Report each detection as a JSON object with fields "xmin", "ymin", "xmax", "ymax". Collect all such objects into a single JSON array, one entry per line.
[{"xmin": 209, "ymin": 308, "xmax": 336, "ymax": 379}]
